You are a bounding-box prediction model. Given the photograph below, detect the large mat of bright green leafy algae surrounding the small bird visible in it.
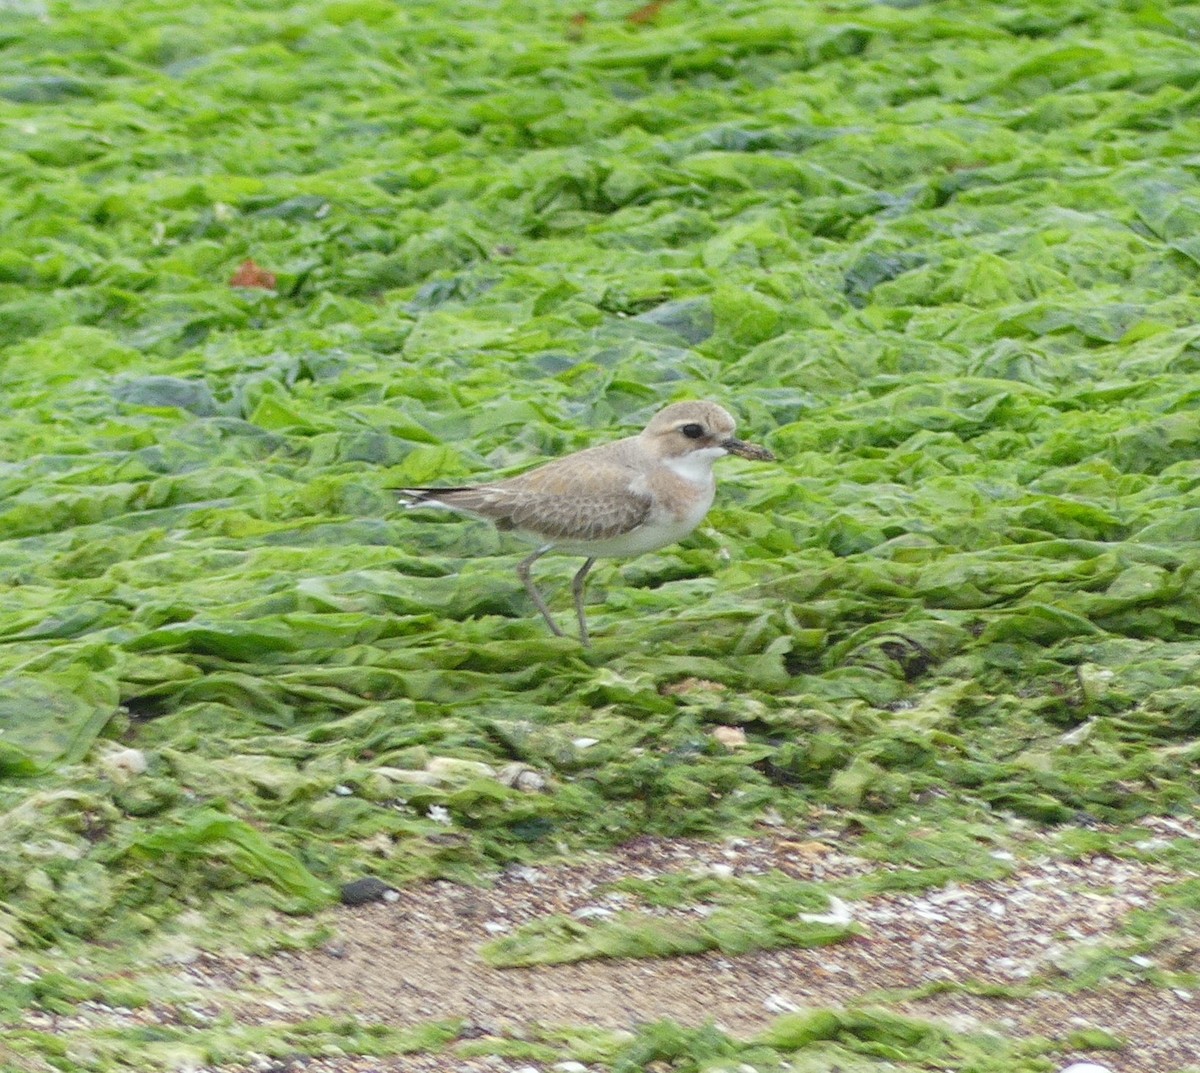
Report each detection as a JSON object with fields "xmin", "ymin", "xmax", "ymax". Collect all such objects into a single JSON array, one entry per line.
[{"xmin": 0, "ymin": 0, "xmax": 1200, "ymax": 1068}]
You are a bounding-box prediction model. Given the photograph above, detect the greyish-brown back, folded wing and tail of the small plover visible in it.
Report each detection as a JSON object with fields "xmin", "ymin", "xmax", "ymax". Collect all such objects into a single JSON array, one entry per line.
[{"xmin": 403, "ymin": 452, "xmax": 650, "ymax": 540}]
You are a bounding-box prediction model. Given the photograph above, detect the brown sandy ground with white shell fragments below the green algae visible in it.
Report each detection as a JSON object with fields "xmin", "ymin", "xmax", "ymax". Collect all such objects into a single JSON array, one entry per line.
[{"xmin": 140, "ymin": 821, "xmax": 1200, "ymax": 1073}]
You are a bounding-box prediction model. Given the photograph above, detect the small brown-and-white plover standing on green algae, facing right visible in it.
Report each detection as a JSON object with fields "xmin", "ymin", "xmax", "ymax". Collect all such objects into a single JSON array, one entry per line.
[{"xmin": 400, "ymin": 402, "xmax": 775, "ymax": 646}]
